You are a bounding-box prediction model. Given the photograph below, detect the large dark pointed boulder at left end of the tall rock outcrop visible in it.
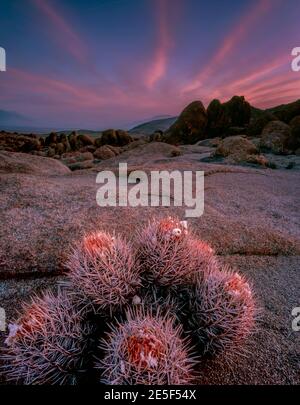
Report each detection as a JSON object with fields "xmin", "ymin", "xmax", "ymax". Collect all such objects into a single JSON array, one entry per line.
[{"xmin": 164, "ymin": 101, "xmax": 207, "ymax": 145}]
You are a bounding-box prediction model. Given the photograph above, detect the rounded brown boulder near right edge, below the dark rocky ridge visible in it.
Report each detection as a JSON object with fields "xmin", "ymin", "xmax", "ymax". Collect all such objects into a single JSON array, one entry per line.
[{"xmin": 260, "ymin": 121, "xmax": 291, "ymax": 154}]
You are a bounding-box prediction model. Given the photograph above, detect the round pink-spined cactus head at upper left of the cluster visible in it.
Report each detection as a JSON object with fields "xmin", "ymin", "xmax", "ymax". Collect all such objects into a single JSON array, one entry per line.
[{"xmin": 67, "ymin": 232, "xmax": 140, "ymax": 314}]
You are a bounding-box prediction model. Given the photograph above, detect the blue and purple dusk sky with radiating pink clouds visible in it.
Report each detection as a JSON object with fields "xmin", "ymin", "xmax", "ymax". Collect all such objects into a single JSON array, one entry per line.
[{"xmin": 0, "ymin": 0, "xmax": 300, "ymax": 129}]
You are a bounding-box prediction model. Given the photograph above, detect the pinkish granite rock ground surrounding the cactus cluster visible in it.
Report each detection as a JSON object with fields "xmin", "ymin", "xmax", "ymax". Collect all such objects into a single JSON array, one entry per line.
[{"xmin": 0, "ymin": 148, "xmax": 300, "ymax": 384}]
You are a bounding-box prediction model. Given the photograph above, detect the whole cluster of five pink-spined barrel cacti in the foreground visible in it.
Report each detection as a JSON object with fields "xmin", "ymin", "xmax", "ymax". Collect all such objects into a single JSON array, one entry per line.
[{"xmin": 1, "ymin": 217, "xmax": 256, "ymax": 385}]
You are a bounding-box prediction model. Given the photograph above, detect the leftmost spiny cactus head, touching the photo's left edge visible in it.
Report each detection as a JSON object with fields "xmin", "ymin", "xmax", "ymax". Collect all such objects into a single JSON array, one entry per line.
[{"xmin": 1, "ymin": 291, "xmax": 91, "ymax": 385}]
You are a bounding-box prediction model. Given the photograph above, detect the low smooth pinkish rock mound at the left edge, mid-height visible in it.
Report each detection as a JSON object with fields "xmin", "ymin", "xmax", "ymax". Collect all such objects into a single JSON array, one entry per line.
[{"xmin": 0, "ymin": 152, "xmax": 70, "ymax": 176}]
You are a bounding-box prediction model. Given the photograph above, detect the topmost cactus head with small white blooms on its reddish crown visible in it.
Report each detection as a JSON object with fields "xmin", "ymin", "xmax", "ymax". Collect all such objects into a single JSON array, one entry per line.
[{"xmin": 138, "ymin": 217, "xmax": 213, "ymax": 286}]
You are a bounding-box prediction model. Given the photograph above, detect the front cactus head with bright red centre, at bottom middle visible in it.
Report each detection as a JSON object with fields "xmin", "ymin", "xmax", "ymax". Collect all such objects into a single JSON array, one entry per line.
[{"xmin": 97, "ymin": 311, "xmax": 196, "ymax": 385}]
